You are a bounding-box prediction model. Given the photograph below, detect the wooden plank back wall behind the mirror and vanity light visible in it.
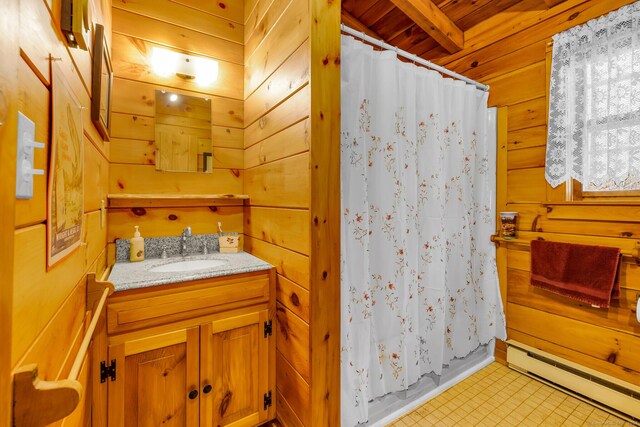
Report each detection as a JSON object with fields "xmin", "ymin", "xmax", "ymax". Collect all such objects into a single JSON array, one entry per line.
[{"xmin": 108, "ymin": 0, "xmax": 244, "ymax": 254}]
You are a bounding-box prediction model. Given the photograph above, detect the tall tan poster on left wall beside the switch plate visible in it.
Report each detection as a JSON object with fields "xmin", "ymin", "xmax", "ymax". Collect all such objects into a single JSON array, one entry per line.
[{"xmin": 47, "ymin": 64, "xmax": 84, "ymax": 269}]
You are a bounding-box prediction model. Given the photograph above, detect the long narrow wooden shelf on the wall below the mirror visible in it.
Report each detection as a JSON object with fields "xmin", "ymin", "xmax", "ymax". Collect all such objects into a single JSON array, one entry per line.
[{"xmin": 107, "ymin": 194, "xmax": 249, "ymax": 208}]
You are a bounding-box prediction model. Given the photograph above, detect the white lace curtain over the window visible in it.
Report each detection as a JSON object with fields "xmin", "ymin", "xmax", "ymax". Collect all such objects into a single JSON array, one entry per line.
[{"xmin": 545, "ymin": 2, "xmax": 640, "ymax": 191}]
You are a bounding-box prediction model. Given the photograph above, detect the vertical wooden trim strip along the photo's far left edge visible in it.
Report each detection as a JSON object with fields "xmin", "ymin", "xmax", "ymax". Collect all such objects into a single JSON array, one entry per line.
[{"xmin": 0, "ymin": 0, "xmax": 20, "ymax": 426}]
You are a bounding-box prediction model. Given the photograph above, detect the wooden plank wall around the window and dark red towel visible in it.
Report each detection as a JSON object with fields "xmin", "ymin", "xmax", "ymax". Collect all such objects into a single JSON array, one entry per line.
[{"xmin": 438, "ymin": 0, "xmax": 640, "ymax": 385}]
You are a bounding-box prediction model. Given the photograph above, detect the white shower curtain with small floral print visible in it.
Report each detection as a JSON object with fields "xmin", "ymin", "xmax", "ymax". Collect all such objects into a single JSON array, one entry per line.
[{"xmin": 341, "ymin": 36, "xmax": 505, "ymax": 427}]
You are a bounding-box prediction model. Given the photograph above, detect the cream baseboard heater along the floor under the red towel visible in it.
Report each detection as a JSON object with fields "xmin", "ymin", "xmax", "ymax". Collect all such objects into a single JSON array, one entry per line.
[{"xmin": 507, "ymin": 340, "xmax": 640, "ymax": 423}]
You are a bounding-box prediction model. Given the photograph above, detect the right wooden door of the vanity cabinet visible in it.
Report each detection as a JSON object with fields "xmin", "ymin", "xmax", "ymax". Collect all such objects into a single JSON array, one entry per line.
[{"xmin": 200, "ymin": 310, "xmax": 275, "ymax": 427}]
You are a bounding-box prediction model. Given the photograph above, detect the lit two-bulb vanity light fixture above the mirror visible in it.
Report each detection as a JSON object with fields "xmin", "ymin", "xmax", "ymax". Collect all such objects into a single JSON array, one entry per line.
[{"xmin": 151, "ymin": 46, "xmax": 218, "ymax": 86}]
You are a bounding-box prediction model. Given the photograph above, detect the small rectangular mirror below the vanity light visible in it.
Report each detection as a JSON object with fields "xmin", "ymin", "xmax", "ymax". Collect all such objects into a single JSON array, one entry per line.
[{"xmin": 155, "ymin": 90, "xmax": 213, "ymax": 173}]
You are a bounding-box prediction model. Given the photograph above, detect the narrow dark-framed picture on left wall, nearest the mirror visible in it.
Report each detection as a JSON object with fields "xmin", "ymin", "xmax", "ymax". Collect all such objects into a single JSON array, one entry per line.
[{"xmin": 91, "ymin": 24, "xmax": 113, "ymax": 141}]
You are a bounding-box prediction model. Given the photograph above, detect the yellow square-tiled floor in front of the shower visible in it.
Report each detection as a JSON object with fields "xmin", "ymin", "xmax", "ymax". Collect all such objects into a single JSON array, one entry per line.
[{"xmin": 389, "ymin": 362, "xmax": 634, "ymax": 427}]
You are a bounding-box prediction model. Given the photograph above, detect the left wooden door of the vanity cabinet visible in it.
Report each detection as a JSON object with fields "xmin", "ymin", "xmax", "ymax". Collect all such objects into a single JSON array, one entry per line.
[{"xmin": 108, "ymin": 327, "xmax": 200, "ymax": 427}]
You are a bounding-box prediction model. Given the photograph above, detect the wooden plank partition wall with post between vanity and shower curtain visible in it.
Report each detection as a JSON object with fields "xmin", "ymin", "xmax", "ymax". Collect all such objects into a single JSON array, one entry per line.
[{"xmin": 244, "ymin": 0, "xmax": 340, "ymax": 426}]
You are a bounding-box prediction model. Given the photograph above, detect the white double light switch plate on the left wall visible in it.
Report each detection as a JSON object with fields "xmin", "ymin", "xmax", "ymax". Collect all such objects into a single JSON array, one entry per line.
[{"xmin": 16, "ymin": 112, "xmax": 44, "ymax": 199}]
